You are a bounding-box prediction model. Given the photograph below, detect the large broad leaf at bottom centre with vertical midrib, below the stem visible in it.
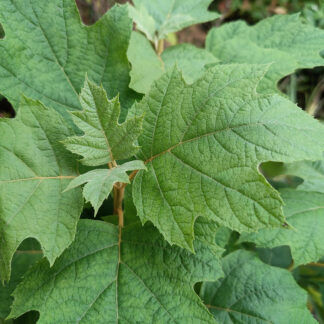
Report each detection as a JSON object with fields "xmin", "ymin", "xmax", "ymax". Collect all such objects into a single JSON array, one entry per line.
[{"xmin": 10, "ymin": 220, "xmax": 222, "ymax": 324}]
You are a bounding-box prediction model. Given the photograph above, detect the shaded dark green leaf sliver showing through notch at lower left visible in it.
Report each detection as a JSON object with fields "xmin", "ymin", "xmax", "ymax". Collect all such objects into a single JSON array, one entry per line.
[{"xmin": 0, "ymin": 239, "xmax": 42, "ymax": 322}]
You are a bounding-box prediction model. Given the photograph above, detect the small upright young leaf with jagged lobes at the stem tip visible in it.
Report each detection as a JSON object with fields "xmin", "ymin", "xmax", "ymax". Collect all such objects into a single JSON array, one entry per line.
[{"xmin": 63, "ymin": 79, "xmax": 143, "ymax": 166}]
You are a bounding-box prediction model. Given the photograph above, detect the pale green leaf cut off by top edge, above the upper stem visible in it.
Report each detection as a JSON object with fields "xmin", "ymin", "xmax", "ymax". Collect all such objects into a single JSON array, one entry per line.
[{"xmin": 129, "ymin": 0, "xmax": 219, "ymax": 43}]
